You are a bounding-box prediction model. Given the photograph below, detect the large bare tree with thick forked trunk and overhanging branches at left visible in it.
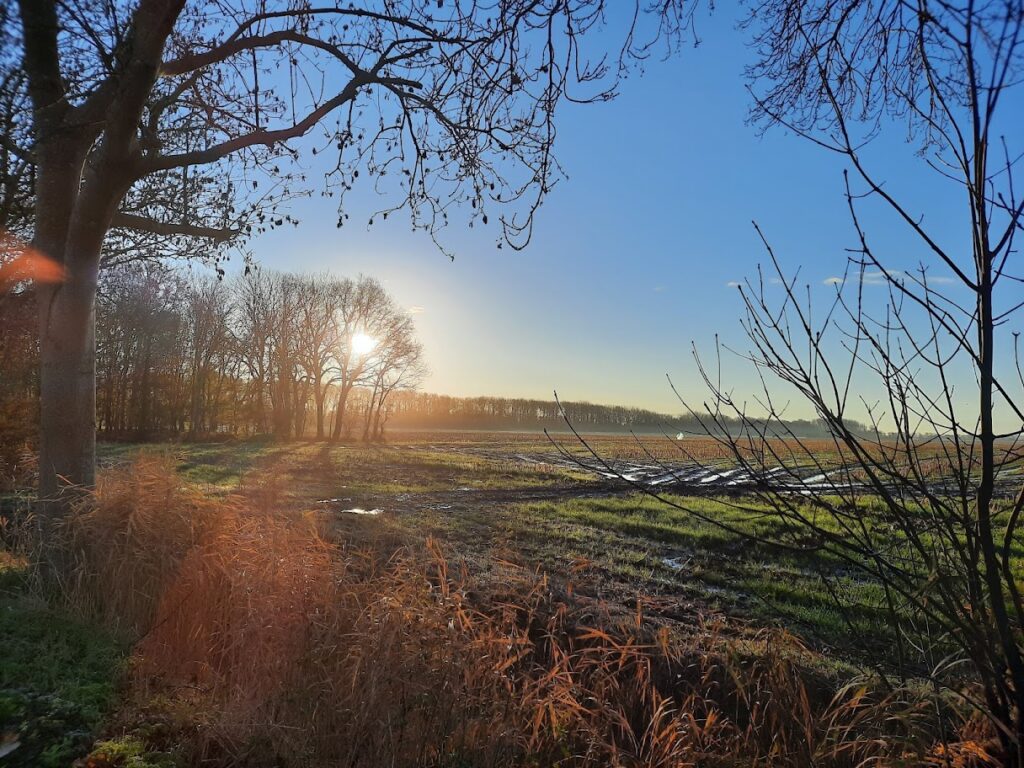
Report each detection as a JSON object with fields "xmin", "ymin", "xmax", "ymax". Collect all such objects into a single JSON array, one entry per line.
[{"xmin": 0, "ymin": 0, "xmax": 688, "ymax": 513}]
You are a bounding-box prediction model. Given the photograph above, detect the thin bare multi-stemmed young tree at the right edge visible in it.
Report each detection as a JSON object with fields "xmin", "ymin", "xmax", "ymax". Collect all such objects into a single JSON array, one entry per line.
[{"xmin": 565, "ymin": 0, "xmax": 1024, "ymax": 766}]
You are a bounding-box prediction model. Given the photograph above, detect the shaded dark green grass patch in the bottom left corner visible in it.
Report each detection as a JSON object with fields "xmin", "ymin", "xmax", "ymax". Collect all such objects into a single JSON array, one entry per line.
[{"xmin": 0, "ymin": 552, "xmax": 126, "ymax": 768}]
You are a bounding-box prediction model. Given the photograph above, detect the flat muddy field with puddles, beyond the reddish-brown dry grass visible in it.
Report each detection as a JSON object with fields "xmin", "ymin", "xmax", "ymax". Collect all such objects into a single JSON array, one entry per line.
[{"xmin": 92, "ymin": 433, "xmax": 929, "ymax": 659}]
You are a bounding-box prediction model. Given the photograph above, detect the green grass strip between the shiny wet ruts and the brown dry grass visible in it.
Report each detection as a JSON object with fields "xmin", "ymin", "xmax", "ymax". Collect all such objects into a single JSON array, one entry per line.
[{"xmin": 391, "ymin": 495, "xmax": 892, "ymax": 657}]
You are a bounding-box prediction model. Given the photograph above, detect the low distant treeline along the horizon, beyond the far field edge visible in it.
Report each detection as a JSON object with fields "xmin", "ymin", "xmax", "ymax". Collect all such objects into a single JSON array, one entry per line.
[{"xmin": 380, "ymin": 391, "xmax": 866, "ymax": 437}]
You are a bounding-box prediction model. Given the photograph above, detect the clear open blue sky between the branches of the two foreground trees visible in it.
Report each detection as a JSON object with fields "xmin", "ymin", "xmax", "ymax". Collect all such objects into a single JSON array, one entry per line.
[{"xmin": 241, "ymin": 4, "xmax": 1024, "ymax": 417}]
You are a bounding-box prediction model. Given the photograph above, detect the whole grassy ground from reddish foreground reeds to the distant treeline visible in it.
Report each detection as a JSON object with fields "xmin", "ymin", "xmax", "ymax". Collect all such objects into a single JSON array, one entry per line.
[{"xmin": 0, "ymin": 433, "xmax": 1024, "ymax": 768}]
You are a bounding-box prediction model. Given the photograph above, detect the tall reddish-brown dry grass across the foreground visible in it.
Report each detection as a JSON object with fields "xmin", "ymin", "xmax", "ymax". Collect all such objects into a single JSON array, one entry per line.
[{"xmin": 48, "ymin": 458, "xmax": 999, "ymax": 767}]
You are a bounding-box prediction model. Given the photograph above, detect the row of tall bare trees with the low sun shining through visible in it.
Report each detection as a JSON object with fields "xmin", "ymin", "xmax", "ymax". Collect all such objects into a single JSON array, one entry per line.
[{"xmin": 0, "ymin": 264, "xmax": 425, "ymax": 441}]
